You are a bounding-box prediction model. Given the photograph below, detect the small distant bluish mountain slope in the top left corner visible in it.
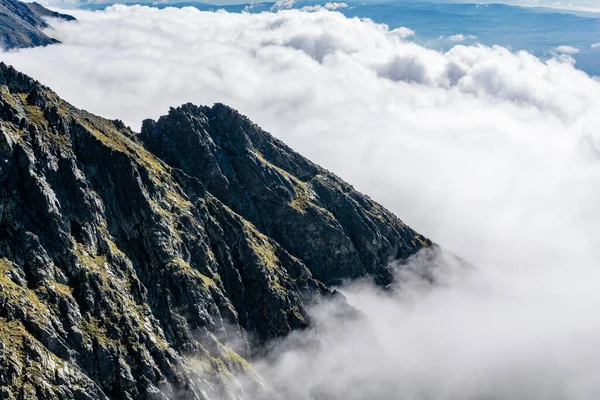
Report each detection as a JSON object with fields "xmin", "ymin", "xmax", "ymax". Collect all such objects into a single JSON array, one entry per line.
[{"xmin": 0, "ymin": 0, "xmax": 75, "ymax": 50}]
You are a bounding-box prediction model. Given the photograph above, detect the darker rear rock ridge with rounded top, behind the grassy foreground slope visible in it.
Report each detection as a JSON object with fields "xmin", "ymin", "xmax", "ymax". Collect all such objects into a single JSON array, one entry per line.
[{"xmin": 141, "ymin": 104, "xmax": 431, "ymax": 285}]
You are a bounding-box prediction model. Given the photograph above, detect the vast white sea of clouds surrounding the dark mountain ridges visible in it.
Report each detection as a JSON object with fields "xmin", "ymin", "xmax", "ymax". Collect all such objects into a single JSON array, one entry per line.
[{"xmin": 0, "ymin": 6, "xmax": 600, "ymax": 400}]
